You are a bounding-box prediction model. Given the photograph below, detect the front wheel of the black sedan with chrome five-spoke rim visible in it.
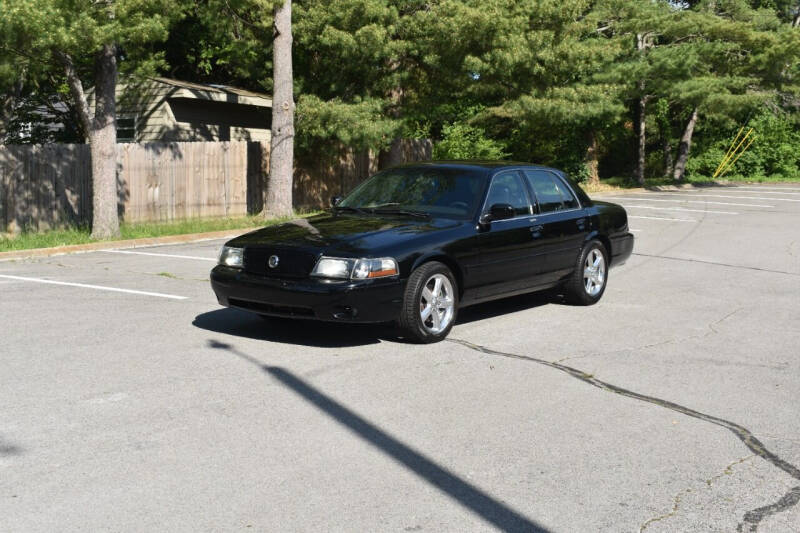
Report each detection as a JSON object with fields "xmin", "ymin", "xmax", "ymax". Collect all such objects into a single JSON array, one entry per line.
[{"xmin": 399, "ymin": 261, "xmax": 458, "ymax": 343}]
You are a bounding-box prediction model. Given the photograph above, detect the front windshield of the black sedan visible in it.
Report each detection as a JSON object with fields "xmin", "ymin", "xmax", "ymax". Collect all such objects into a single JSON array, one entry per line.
[{"xmin": 337, "ymin": 167, "xmax": 485, "ymax": 219}]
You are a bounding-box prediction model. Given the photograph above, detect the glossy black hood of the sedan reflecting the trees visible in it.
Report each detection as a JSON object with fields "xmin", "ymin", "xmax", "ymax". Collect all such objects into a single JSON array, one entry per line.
[{"xmin": 228, "ymin": 212, "xmax": 464, "ymax": 255}]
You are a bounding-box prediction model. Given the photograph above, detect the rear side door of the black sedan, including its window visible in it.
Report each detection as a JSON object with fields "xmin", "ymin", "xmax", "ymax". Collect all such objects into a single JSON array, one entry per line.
[{"xmin": 524, "ymin": 169, "xmax": 589, "ymax": 282}]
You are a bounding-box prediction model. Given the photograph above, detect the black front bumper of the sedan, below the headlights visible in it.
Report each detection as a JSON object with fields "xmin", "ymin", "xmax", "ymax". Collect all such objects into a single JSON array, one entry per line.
[{"xmin": 211, "ymin": 265, "xmax": 405, "ymax": 323}]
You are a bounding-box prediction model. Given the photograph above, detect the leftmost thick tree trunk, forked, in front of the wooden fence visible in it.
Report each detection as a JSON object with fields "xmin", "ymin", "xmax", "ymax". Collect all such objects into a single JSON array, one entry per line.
[{"xmin": 89, "ymin": 44, "xmax": 119, "ymax": 239}]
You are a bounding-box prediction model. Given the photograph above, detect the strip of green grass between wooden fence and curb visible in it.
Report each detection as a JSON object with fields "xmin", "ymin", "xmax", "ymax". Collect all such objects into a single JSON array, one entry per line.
[{"xmin": 0, "ymin": 213, "xmax": 313, "ymax": 252}]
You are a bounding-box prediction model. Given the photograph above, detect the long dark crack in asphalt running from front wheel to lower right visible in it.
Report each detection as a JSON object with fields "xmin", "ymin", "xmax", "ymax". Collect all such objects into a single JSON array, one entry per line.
[{"xmin": 446, "ymin": 337, "xmax": 800, "ymax": 532}]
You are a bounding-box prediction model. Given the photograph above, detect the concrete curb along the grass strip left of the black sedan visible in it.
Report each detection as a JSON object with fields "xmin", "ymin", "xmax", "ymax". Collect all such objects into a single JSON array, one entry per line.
[{"xmin": 0, "ymin": 227, "xmax": 253, "ymax": 262}]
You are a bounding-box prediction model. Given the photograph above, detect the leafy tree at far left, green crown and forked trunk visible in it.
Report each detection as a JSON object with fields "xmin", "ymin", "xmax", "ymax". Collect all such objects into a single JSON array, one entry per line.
[{"xmin": 0, "ymin": 0, "xmax": 176, "ymax": 238}]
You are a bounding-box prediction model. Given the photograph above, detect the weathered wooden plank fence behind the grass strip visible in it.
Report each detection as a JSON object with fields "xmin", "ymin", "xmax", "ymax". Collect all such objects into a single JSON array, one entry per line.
[{"xmin": 0, "ymin": 141, "xmax": 430, "ymax": 233}]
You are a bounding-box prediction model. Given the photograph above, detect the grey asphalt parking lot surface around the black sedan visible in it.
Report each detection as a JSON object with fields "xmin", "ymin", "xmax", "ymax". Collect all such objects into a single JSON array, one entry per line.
[{"xmin": 0, "ymin": 184, "xmax": 800, "ymax": 532}]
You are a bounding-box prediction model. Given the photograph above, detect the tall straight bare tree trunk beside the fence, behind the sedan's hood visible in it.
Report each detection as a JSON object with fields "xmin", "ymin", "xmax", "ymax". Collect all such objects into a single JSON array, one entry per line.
[{"xmin": 264, "ymin": 0, "xmax": 294, "ymax": 217}]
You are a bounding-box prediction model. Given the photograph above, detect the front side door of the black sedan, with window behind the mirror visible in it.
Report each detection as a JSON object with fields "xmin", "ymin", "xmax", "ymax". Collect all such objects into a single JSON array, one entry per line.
[{"xmin": 473, "ymin": 170, "xmax": 539, "ymax": 299}]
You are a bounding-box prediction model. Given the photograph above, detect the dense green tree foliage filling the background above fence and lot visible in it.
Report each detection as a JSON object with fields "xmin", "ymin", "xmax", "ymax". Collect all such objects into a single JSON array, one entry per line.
[{"xmin": 0, "ymin": 0, "xmax": 800, "ymax": 180}]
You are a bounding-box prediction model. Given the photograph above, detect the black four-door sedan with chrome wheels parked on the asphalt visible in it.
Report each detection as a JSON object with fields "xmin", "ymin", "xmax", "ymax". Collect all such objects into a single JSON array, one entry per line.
[{"xmin": 211, "ymin": 162, "xmax": 633, "ymax": 342}]
